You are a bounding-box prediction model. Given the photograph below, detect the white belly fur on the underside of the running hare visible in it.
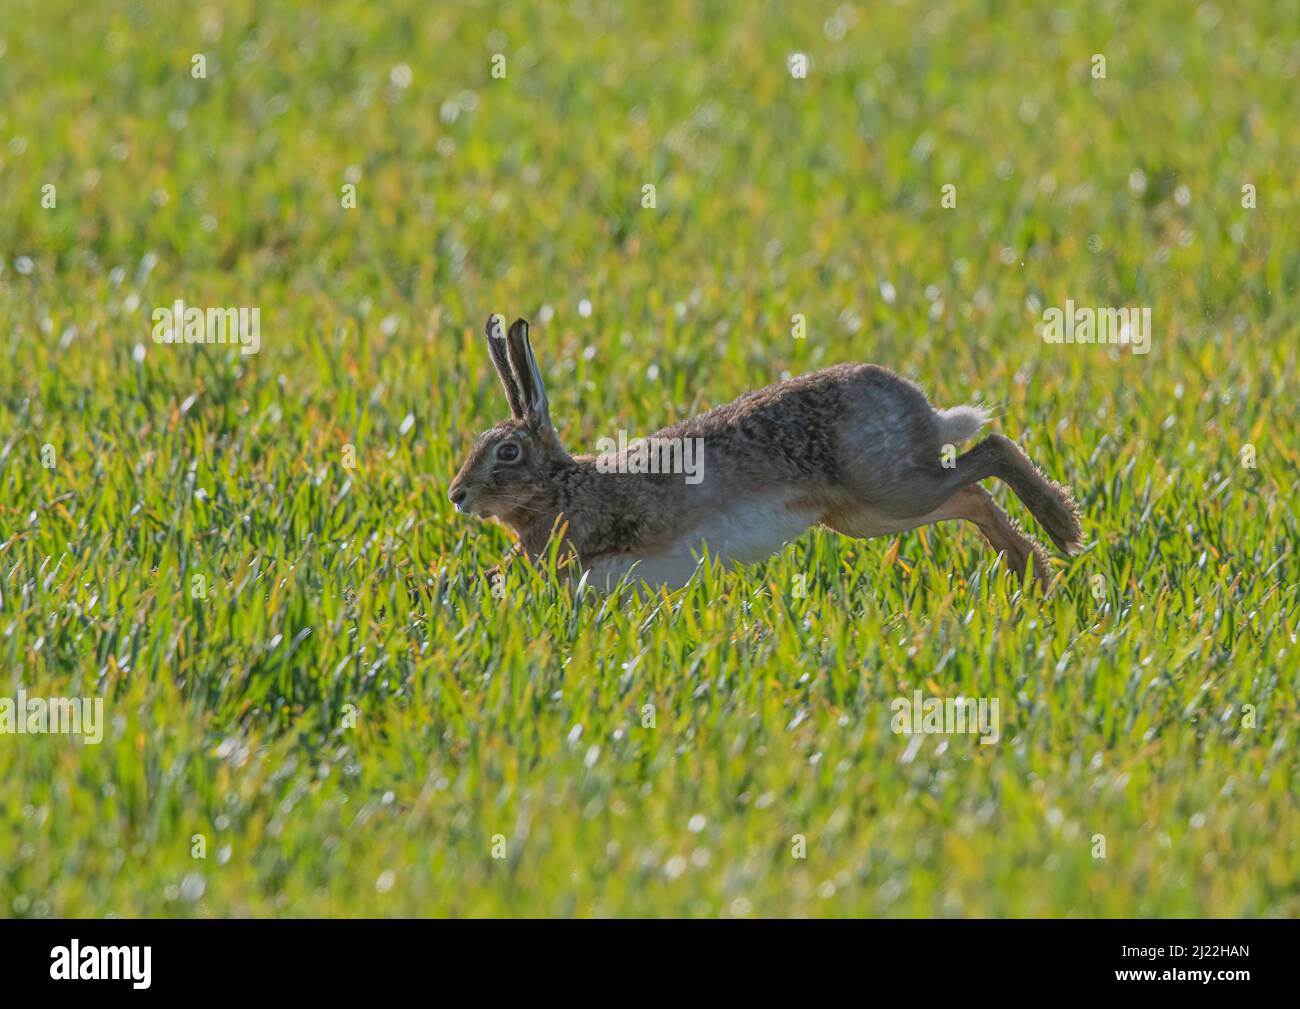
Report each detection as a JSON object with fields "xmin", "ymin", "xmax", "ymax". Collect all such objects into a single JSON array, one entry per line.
[{"xmin": 588, "ymin": 498, "xmax": 819, "ymax": 589}]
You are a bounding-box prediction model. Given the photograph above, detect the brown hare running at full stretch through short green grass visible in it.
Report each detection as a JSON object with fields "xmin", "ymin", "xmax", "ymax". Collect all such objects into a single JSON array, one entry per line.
[{"xmin": 449, "ymin": 316, "xmax": 1080, "ymax": 590}]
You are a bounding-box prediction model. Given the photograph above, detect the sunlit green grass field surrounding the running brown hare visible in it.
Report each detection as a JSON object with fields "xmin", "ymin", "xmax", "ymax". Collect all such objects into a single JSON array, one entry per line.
[{"xmin": 0, "ymin": 0, "xmax": 1300, "ymax": 917}]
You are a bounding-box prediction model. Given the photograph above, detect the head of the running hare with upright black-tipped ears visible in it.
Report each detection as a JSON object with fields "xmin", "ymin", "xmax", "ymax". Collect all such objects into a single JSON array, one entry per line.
[{"xmin": 447, "ymin": 316, "xmax": 573, "ymax": 520}]
